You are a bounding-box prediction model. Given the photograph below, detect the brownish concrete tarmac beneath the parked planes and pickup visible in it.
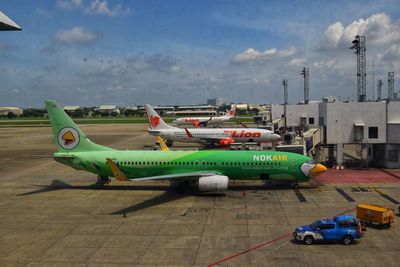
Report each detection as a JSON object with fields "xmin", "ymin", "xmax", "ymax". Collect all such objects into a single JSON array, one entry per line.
[{"xmin": 0, "ymin": 124, "xmax": 400, "ymax": 266}]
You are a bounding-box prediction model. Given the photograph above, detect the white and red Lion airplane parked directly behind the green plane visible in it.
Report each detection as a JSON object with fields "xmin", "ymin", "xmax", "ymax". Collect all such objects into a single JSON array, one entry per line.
[{"xmin": 146, "ymin": 105, "xmax": 281, "ymax": 146}]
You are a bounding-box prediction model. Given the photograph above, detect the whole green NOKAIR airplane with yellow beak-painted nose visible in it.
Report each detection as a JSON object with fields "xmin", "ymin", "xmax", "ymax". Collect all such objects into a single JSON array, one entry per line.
[{"xmin": 45, "ymin": 100, "xmax": 326, "ymax": 191}]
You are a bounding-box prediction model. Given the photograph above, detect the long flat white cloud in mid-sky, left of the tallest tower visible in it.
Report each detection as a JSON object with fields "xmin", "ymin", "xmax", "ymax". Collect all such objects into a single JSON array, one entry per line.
[{"xmin": 233, "ymin": 47, "xmax": 298, "ymax": 64}]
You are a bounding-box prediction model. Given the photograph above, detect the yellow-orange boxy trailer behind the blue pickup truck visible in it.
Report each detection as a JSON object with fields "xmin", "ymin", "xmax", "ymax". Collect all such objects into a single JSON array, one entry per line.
[{"xmin": 357, "ymin": 204, "xmax": 394, "ymax": 227}]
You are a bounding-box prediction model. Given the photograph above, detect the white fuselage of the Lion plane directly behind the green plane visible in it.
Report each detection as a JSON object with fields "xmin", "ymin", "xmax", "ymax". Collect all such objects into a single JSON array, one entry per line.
[{"xmin": 149, "ymin": 128, "xmax": 281, "ymax": 142}]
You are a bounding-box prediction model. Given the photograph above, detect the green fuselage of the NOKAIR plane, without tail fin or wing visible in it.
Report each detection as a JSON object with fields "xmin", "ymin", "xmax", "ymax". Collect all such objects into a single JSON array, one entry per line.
[{"xmin": 54, "ymin": 150, "xmax": 315, "ymax": 181}]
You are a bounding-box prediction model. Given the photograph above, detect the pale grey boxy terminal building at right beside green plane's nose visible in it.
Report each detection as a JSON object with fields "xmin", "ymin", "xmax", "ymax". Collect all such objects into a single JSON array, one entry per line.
[{"xmin": 271, "ymin": 100, "xmax": 400, "ymax": 168}]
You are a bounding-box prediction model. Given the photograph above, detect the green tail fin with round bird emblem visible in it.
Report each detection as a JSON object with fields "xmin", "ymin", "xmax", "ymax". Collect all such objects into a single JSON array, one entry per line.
[{"xmin": 45, "ymin": 100, "xmax": 112, "ymax": 152}]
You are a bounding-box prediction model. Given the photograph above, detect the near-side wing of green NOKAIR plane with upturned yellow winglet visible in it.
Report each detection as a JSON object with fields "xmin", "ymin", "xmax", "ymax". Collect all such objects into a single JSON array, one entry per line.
[{"xmin": 107, "ymin": 158, "xmax": 221, "ymax": 181}]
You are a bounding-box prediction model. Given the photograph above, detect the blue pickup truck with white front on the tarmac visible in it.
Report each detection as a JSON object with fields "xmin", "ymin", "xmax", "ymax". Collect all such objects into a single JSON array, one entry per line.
[{"xmin": 293, "ymin": 214, "xmax": 362, "ymax": 245}]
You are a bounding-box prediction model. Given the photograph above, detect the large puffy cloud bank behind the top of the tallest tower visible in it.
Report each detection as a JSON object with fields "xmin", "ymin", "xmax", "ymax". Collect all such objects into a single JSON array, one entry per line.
[{"xmin": 318, "ymin": 13, "xmax": 400, "ymax": 50}]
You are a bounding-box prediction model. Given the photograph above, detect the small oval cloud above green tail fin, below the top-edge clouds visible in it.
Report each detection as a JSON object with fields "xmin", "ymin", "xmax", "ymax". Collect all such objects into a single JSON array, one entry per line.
[{"xmin": 56, "ymin": 27, "xmax": 100, "ymax": 44}]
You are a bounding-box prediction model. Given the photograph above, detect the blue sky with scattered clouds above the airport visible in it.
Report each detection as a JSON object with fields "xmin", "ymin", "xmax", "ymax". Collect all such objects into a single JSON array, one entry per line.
[{"xmin": 0, "ymin": 0, "xmax": 400, "ymax": 107}]
